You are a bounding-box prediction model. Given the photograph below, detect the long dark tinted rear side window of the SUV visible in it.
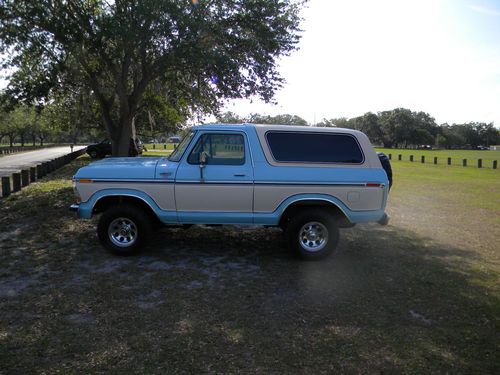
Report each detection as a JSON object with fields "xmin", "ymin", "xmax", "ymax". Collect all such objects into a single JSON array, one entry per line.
[{"xmin": 266, "ymin": 131, "xmax": 364, "ymax": 164}]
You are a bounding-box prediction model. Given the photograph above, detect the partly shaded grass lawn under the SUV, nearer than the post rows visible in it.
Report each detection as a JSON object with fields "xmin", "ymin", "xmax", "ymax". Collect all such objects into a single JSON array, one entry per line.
[{"xmin": 0, "ymin": 156, "xmax": 500, "ymax": 374}]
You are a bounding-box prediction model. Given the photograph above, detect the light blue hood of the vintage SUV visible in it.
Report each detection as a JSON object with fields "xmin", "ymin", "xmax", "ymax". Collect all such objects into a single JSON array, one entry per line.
[{"xmin": 74, "ymin": 157, "xmax": 164, "ymax": 180}]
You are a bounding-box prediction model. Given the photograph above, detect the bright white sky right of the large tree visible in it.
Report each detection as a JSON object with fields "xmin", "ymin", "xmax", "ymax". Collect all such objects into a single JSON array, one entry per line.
[{"xmin": 225, "ymin": 0, "xmax": 500, "ymax": 127}]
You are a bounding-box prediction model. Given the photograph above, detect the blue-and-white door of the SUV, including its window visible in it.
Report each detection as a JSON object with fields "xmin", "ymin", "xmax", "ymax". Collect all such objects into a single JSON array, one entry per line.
[{"xmin": 175, "ymin": 131, "xmax": 253, "ymax": 224}]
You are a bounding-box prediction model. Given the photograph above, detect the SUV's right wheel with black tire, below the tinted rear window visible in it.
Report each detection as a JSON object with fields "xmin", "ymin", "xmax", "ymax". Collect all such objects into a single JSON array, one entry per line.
[{"xmin": 286, "ymin": 209, "xmax": 339, "ymax": 260}]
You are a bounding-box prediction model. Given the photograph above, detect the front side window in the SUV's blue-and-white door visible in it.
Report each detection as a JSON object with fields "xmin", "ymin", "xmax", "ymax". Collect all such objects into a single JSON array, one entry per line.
[{"xmin": 188, "ymin": 133, "xmax": 245, "ymax": 165}]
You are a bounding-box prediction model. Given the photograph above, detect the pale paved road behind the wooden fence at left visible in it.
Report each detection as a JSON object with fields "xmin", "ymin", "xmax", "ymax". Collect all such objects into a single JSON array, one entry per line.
[{"xmin": 0, "ymin": 146, "xmax": 85, "ymax": 176}]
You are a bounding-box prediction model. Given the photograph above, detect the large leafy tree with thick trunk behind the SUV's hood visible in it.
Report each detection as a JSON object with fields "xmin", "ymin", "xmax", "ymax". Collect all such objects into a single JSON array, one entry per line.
[{"xmin": 0, "ymin": 0, "xmax": 303, "ymax": 155}]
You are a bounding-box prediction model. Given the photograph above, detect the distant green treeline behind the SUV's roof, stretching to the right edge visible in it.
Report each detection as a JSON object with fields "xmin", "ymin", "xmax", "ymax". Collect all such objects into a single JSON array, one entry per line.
[{"xmin": 217, "ymin": 108, "xmax": 500, "ymax": 148}]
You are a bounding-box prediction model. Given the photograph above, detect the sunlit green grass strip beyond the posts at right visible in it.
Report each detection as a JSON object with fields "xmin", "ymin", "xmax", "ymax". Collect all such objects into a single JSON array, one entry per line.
[{"xmin": 376, "ymin": 148, "xmax": 500, "ymax": 168}]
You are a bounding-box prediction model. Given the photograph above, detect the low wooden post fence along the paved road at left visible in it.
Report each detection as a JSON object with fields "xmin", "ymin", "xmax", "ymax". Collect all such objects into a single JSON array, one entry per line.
[{"xmin": 2, "ymin": 148, "xmax": 86, "ymax": 198}]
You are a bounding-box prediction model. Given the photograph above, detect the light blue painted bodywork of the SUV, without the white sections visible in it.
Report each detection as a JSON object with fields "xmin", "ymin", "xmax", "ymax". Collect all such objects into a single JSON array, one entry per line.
[{"xmin": 75, "ymin": 124, "xmax": 388, "ymax": 225}]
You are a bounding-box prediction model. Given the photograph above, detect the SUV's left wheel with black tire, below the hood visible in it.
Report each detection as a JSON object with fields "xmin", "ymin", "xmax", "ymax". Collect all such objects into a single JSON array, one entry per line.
[{"xmin": 97, "ymin": 204, "xmax": 151, "ymax": 256}]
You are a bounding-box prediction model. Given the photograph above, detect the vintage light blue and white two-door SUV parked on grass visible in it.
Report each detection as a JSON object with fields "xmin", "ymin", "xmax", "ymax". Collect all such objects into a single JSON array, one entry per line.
[{"xmin": 71, "ymin": 124, "xmax": 392, "ymax": 259}]
